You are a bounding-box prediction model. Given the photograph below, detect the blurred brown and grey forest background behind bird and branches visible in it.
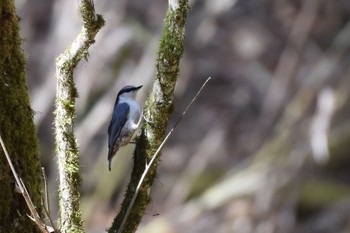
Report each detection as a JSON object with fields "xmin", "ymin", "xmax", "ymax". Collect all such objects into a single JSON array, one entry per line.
[{"xmin": 16, "ymin": 0, "xmax": 350, "ymax": 233}]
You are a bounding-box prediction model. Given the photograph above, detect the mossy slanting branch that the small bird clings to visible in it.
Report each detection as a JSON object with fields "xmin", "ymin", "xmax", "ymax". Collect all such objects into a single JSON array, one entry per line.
[{"xmin": 108, "ymin": 0, "xmax": 188, "ymax": 233}]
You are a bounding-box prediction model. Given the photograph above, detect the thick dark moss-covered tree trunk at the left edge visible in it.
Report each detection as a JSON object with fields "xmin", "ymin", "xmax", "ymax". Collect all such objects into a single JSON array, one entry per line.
[{"xmin": 0, "ymin": 0, "xmax": 41, "ymax": 232}]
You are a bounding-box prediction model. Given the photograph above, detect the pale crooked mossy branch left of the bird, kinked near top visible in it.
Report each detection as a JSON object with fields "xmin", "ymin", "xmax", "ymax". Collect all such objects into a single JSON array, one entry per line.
[{"xmin": 55, "ymin": 0, "xmax": 104, "ymax": 232}]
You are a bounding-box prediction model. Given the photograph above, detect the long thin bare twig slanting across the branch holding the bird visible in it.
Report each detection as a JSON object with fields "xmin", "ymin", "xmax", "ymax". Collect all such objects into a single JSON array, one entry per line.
[{"xmin": 118, "ymin": 77, "xmax": 211, "ymax": 233}]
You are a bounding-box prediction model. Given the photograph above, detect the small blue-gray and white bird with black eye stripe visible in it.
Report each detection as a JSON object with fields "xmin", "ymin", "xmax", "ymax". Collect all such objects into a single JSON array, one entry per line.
[{"xmin": 108, "ymin": 85, "xmax": 142, "ymax": 170}]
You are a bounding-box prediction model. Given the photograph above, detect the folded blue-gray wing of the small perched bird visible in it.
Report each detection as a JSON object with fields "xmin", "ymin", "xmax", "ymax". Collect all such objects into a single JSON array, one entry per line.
[{"xmin": 108, "ymin": 103, "xmax": 130, "ymax": 150}]
